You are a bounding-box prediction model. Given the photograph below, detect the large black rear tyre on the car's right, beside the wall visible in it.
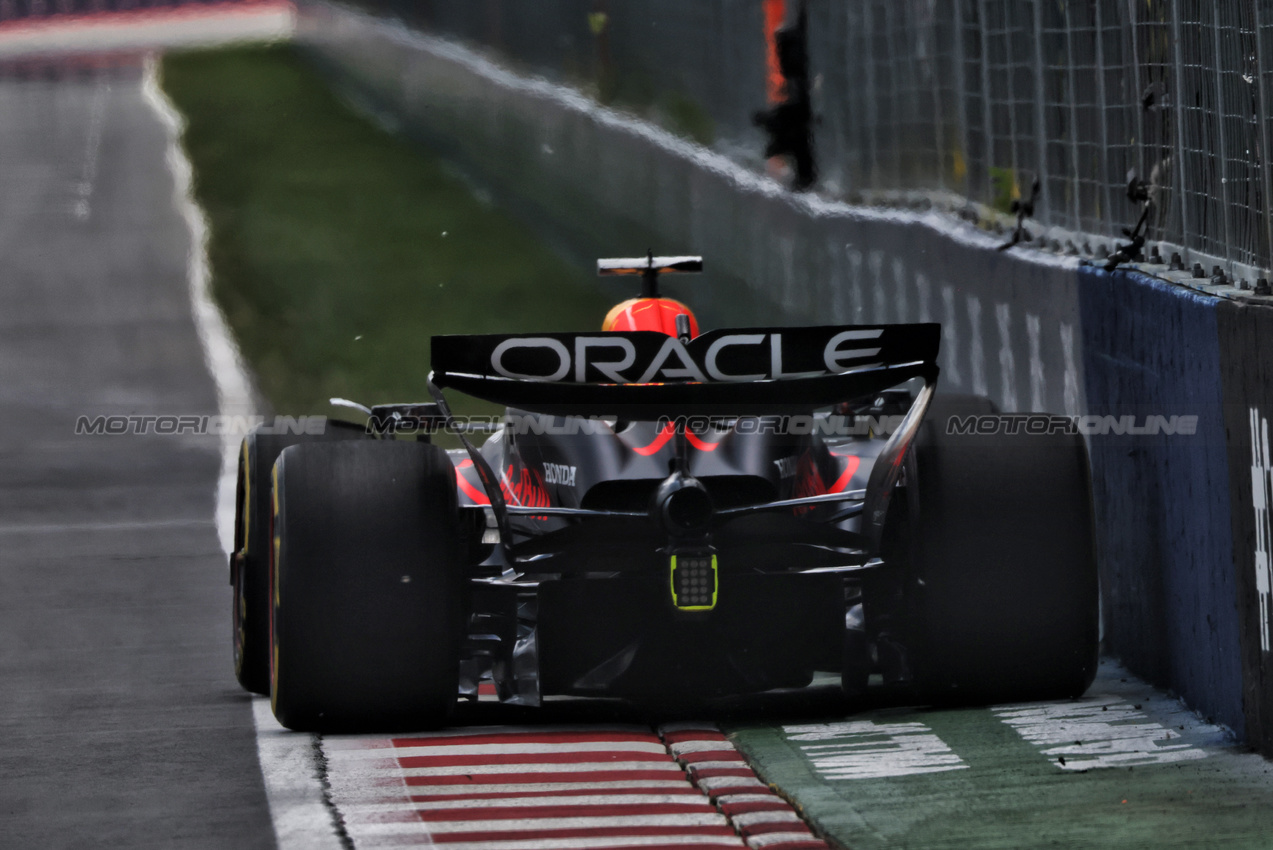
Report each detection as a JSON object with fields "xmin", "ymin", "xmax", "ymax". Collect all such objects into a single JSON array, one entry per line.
[{"xmin": 906, "ymin": 396, "xmax": 1100, "ymax": 704}]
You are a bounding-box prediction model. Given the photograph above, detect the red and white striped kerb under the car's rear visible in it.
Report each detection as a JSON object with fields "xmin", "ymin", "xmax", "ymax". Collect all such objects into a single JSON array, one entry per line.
[{"xmin": 322, "ymin": 724, "xmax": 827, "ymax": 850}]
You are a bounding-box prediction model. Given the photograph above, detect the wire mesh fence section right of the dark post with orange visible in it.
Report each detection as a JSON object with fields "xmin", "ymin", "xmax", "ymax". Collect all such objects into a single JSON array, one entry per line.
[{"xmin": 810, "ymin": 0, "xmax": 1273, "ymax": 268}]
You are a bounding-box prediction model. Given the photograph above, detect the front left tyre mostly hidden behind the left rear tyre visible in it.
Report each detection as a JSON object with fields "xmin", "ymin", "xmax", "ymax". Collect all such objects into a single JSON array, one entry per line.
[{"xmin": 230, "ymin": 420, "xmax": 370, "ymax": 695}]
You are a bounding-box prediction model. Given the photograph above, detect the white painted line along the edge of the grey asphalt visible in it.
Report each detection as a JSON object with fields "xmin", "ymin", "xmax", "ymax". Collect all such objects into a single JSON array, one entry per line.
[{"xmin": 141, "ymin": 56, "xmax": 342, "ymax": 850}]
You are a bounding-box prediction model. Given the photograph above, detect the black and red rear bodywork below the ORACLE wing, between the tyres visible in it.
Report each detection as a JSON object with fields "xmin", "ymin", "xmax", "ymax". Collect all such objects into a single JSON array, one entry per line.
[{"xmin": 456, "ymin": 411, "xmax": 885, "ymax": 702}]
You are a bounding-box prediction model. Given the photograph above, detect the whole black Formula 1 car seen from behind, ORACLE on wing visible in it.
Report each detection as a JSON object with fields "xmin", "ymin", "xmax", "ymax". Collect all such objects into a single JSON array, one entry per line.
[{"xmin": 230, "ymin": 256, "xmax": 1097, "ymax": 730}]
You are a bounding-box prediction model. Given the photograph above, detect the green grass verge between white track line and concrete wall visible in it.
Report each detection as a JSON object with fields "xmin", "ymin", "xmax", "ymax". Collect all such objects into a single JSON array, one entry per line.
[{"xmin": 162, "ymin": 46, "xmax": 608, "ymax": 414}]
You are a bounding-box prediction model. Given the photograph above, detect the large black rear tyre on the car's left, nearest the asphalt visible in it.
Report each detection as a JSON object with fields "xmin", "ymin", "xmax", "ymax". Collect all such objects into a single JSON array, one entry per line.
[{"xmin": 270, "ymin": 440, "xmax": 465, "ymax": 732}]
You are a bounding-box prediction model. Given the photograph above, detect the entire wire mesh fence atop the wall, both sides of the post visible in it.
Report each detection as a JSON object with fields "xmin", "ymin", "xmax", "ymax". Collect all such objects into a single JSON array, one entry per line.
[{"xmin": 9, "ymin": 0, "xmax": 1273, "ymax": 270}]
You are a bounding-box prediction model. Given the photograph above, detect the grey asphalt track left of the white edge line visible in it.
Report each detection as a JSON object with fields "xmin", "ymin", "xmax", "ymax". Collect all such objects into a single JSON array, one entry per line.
[{"xmin": 0, "ymin": 67, "xmax": 274, "ymax": 847}]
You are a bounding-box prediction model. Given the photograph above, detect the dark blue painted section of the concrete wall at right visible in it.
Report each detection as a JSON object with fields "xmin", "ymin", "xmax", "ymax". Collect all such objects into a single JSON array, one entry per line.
[{"xmin": 1078, "ymin": 267, "xmax": 1244, "ymax": 733}]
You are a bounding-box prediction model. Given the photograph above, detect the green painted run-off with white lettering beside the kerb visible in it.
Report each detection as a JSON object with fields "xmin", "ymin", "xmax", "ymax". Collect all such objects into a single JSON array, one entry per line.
[{"xmin": 727, "ymin": 665, "xmax": 1273, "ymax": 850}]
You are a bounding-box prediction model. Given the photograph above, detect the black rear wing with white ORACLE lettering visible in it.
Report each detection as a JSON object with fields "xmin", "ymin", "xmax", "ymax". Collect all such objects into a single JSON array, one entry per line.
[{"xmin": 432, "ymin": 324, "xmax": 941, "ymax": 419}]
